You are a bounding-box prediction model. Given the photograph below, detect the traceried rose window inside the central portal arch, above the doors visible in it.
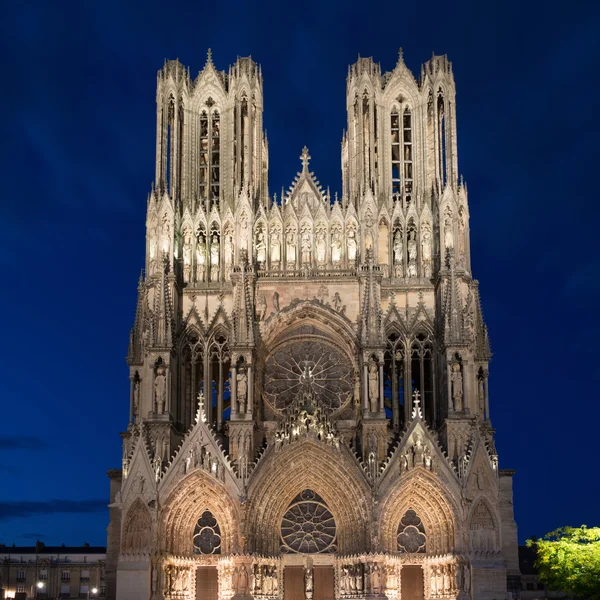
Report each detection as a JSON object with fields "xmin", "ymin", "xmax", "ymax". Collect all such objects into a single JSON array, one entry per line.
[{"xmin": 281, "ymin": 490, "xmax": 337, "ymax": 554}]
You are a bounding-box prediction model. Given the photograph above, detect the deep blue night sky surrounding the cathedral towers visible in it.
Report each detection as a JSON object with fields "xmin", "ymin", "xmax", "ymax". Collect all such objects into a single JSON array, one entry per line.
[{"xmin": 0, "ymin": 0, "xmax": 600, "ymax": 544}]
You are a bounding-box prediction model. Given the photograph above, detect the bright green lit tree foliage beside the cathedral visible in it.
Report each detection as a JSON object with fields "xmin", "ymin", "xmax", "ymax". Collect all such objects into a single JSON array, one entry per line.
[{"xmin": 527, "ymin": 525, "xmax": 600, "ymax": 600}]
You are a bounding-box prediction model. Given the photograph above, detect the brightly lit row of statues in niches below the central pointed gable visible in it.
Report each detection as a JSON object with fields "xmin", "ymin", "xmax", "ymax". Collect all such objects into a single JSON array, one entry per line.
[{"xmin": 255, "ymin": 227, "xmax": 358, "ymax": 269}]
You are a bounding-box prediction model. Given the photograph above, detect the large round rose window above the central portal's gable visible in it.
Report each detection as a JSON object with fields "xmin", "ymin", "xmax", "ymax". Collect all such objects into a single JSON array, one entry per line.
[{"xmin": 264, "ymin": 338, "xmax": 353, "ymax": 412}]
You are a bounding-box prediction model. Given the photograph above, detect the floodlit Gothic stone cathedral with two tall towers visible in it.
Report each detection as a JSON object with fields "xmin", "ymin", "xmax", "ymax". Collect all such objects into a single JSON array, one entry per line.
[{"xmin": 107, "ymin": 52, "xmax": 520, "ymax": 600}]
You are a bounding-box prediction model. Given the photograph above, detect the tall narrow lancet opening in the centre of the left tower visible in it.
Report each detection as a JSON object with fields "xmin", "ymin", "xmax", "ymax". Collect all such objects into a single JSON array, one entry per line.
[{"xmin": 198, "ymin": 108, "xmax": 221, "ymax": 205}]
